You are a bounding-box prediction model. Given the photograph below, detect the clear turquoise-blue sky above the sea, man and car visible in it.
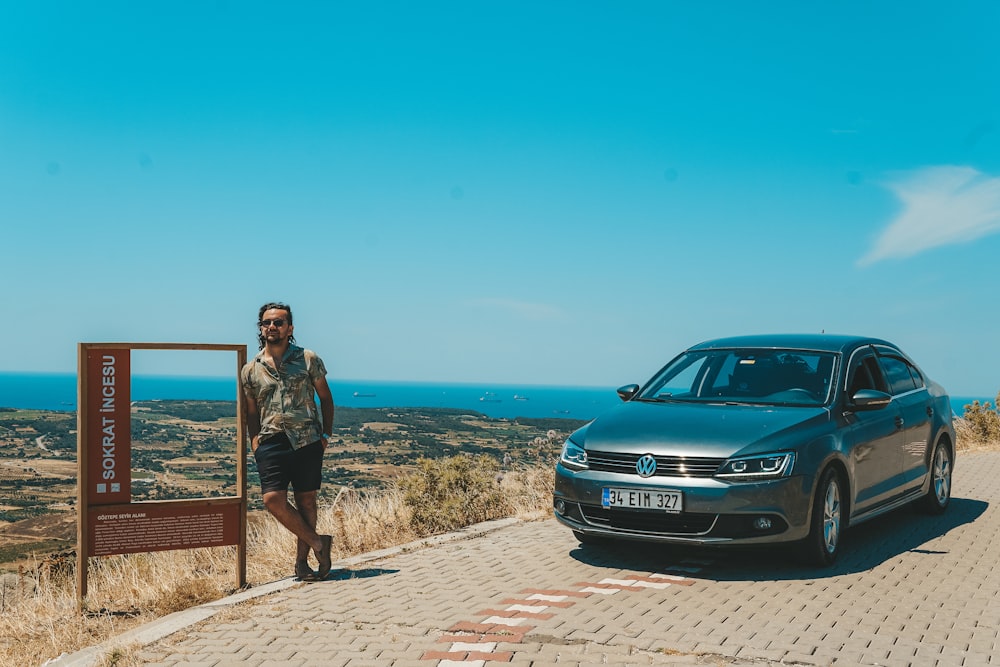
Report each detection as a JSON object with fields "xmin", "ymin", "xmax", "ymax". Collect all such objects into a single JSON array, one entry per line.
[{"xmin": 0, "ymin": 1, "xmax": 1000, "ymax": 396}]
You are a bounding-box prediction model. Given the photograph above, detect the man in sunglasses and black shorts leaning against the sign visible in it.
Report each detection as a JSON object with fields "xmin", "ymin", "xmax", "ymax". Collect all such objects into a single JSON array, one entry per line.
[{"xmin": 240, "ymin": 303, "xmax": 334, "ymax": 581}]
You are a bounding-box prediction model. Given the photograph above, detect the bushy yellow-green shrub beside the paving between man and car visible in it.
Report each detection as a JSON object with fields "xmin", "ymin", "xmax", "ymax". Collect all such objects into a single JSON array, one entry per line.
[{"xmin": 397, "ymin": 454, "xmax": 512, "ymax": 536}]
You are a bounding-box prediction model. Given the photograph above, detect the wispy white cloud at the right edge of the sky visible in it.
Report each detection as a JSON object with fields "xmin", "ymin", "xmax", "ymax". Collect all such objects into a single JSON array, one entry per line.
[{"xmin": 858, "ymin": 166, "xmax": 1000, "ymax": 266}]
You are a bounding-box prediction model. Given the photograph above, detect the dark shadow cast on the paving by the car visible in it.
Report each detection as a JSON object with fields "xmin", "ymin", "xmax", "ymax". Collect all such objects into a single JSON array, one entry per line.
[{"xmin": 570, "ymin": 498, "xmax": 989, "ymax": 581}]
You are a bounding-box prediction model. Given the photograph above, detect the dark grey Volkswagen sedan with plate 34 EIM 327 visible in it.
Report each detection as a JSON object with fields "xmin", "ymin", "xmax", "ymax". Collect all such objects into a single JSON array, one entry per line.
[{"xmin": 553, "ymin": 334, "xmax": 955, "ymax": 566}]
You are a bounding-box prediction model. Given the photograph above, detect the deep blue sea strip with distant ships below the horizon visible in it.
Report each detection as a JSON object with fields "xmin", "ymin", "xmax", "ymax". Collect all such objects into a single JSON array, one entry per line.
[{"xmin": 0, "ymin": 373, "xmax": 995, "ymax": 420}]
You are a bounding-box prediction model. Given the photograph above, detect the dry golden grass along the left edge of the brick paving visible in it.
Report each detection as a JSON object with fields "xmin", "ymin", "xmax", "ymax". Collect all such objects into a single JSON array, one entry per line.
[{"xmin": 0, "ymin": 457, "xmax": 552, "ymax": 667}]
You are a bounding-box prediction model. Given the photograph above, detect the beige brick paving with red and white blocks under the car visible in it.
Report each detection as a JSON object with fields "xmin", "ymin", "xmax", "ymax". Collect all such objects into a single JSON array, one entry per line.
[{"xmin": 58, "ymin": 452, "xmax": 1000, "ymax": 667}]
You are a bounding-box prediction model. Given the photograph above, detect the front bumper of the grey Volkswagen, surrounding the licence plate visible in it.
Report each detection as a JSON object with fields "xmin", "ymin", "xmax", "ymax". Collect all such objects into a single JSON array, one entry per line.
[{"xmin": 553, "ymin": 464, "xmax": 812, "ymax": 545}]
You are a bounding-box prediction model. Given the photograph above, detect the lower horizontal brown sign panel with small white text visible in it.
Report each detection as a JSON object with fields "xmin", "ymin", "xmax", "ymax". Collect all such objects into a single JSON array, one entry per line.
[{"xmin": 87, "ymin": 503, "xmax": 240, "ymax": 556}]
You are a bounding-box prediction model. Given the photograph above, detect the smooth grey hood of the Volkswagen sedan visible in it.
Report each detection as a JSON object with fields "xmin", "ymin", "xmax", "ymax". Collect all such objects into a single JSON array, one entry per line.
[{"xmin": 573, "ymin": 401, "xmax": 829, "ymax": 458}]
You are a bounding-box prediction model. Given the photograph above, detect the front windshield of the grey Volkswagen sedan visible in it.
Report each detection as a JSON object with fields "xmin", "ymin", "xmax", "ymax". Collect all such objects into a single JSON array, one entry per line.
[{"xmin": 638, "ymin": 348, "xmax": 837, "ymax": 406}]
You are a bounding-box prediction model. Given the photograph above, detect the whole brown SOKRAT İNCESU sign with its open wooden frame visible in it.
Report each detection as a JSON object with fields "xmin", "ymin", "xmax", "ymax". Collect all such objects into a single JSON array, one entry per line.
[{"xmin": 76, "ymin": 343, "xmax": 247, "ymax": 606}]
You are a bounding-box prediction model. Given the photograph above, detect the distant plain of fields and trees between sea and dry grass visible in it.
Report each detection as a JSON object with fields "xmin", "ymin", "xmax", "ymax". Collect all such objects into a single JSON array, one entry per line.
[{"xmin": 0, "ymin": 401, "xmax": 585, "ymax": 569}]
